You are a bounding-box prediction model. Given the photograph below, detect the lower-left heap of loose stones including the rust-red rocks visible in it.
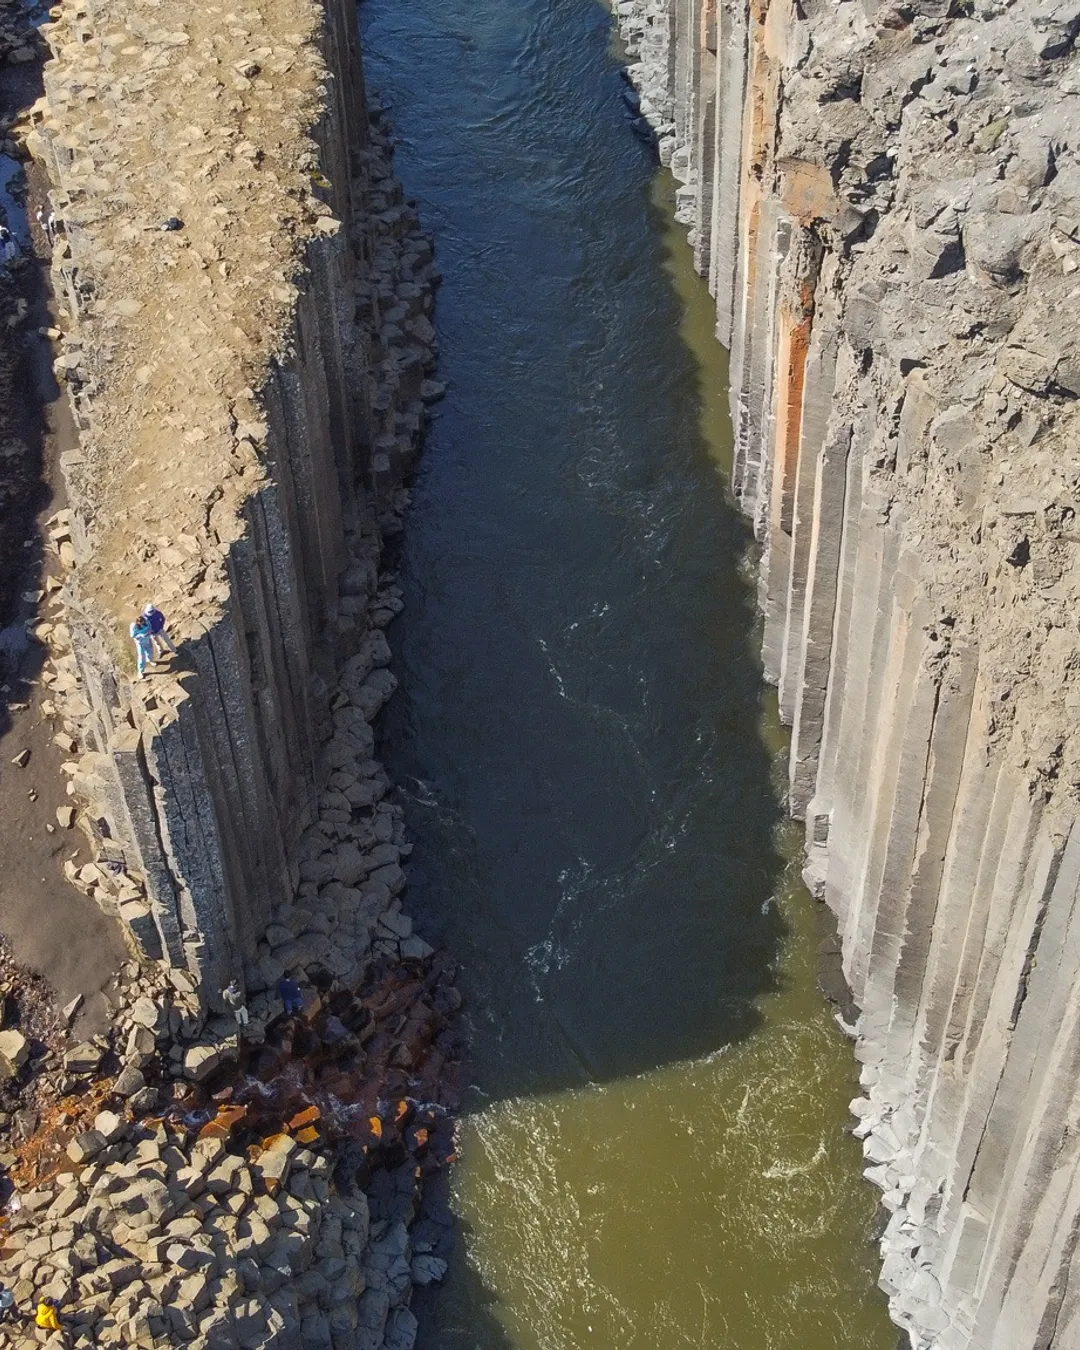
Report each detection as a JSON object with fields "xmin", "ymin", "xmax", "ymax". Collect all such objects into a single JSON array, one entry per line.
[{"xmin": 0, "ymin": 880, "xmax": 458, "ymax": 1350}]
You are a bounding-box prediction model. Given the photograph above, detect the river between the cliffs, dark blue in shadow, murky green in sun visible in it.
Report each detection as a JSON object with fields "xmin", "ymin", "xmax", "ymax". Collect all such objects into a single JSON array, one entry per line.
[{"xmin": 362, "ymin": 0, "xmax": 896, "ymax": 1350}]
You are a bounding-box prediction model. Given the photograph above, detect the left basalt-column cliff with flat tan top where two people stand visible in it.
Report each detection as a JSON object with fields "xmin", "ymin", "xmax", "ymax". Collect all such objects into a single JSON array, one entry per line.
[{"xmin": 30, "ymin": 0, "xmax": 433, "ymax": 990}]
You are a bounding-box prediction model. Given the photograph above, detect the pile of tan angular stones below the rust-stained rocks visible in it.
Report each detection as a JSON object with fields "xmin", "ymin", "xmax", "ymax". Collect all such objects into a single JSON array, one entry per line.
[{"xmin": 0, "ymin": 1110, "xmax": 434, "ymax": 1350}]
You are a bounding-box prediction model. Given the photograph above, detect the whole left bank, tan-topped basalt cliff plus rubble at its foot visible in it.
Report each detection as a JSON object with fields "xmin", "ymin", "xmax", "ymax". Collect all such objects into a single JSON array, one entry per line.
[{"xmin": 0, "ymin": 0, "xmax": 459, "ymax": 1350}]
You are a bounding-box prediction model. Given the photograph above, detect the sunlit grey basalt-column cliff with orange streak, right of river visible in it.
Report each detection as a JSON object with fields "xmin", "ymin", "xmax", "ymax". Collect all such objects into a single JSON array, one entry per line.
[{"xmin": 616, "ymin": 0, "xmax": 1080, "ymax": 1350}]
